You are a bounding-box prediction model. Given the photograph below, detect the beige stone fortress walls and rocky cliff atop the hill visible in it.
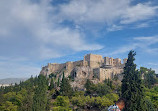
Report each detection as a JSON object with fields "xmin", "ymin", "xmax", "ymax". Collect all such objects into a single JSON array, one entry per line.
[{"xmin": 40, "ymin": 54, "xmax": 127, "ymax": 88}]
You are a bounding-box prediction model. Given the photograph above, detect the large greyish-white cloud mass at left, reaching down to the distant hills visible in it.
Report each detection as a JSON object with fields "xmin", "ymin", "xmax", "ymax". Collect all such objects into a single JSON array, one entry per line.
[{"xmin": 0, "ymin": 0, "xmax": 103, "ymax": 78}]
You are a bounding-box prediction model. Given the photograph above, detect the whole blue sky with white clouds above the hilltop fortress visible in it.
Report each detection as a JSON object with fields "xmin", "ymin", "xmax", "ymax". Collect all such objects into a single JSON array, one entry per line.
[{"xmin": 0, "ymin": 0, "xmax": 158, "ymax": 79}]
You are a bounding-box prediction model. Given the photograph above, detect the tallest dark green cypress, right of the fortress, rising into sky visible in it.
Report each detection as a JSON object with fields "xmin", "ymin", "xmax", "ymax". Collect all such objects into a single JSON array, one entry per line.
[{"xmin": 121, "ymin": 51, "xmax": 147, "ymax": 111}]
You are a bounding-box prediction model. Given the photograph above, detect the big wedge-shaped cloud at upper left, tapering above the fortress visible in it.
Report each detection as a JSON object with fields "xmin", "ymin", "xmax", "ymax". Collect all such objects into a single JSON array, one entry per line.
[{"xmin": 0, "ymin": 0, "xmax": 102, "ymax": 59}]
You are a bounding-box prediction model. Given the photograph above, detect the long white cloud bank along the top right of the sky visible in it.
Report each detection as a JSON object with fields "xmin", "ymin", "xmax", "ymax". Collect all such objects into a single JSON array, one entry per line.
[{"xmin": 59, "ymin": 0, "xmax": 158, "ymax": 24}]
